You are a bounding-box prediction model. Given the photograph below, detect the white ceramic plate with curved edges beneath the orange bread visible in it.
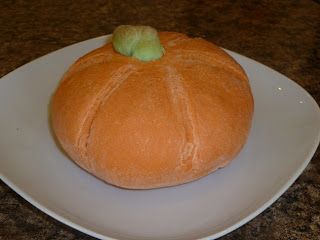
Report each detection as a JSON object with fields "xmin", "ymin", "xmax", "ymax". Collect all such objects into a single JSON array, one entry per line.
[{"xmin": 0, "ymin": 37, "xmax": 320, "ymax": 240}]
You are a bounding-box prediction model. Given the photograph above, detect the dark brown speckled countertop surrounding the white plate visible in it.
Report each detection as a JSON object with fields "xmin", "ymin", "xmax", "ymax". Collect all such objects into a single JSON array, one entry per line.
[{"xmin": 0, "ymin": 0, "xmax": 320, "ymax": 240}]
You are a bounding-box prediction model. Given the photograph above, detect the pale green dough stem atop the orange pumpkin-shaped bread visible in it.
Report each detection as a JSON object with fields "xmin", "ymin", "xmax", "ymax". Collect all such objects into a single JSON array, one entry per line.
[{"xmin": 112, "ymin": 25, "xmax": 164, "ymax": 61}]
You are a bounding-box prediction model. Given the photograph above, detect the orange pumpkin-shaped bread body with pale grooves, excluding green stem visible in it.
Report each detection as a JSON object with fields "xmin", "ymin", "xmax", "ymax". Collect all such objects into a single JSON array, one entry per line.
[{"xmin": 51, "ymin": 32, "xmax": 253, "ymax": 189}]
